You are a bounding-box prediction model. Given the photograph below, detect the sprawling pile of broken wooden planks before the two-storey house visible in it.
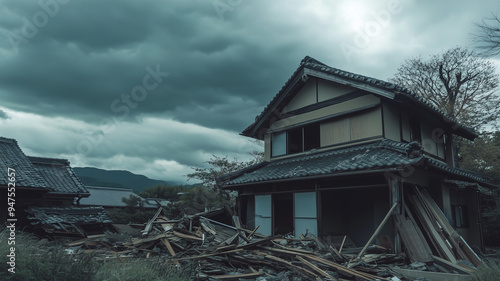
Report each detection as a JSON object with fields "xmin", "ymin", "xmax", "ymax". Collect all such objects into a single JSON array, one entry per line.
[{"xmin": 61, "ymin": 197, "xmax": 480, "ymax": 281}]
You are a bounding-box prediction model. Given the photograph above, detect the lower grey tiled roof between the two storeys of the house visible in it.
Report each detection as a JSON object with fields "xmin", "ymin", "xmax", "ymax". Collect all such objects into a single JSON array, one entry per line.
[{"xmin": 222, "ymin": 139, "xmax": 487, "ymax": 188}]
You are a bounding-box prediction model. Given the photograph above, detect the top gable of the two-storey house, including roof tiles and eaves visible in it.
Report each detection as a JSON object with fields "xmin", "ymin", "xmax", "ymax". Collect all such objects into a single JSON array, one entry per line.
[{"xmin": 241, "ymin": 56, "xmax": 477, "ymax": 140}]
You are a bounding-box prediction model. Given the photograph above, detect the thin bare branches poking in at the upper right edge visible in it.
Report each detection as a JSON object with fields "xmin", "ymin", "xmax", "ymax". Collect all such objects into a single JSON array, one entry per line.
[{"xmin": 473, "ymin": 14, "xmax": 500, "ymax": 56}]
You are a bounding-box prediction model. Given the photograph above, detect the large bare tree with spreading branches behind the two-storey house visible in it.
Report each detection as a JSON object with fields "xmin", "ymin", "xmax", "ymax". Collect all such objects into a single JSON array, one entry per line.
[{"xmin": 389, "ymin": 47, "xmax": 500, "ymax": 130}]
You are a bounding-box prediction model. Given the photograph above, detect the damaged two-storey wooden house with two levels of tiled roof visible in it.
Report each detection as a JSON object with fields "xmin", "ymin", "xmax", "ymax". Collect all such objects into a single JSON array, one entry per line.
[{"xmin": 218, "ymin": 57, "xmax": 495, "ymax": 252}]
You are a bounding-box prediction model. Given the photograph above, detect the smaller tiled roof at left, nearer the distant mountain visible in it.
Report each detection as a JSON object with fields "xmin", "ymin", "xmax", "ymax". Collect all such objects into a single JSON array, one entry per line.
[{"xmin": 28, "ymin": 156, "xmax": 88, "ymax": 193}]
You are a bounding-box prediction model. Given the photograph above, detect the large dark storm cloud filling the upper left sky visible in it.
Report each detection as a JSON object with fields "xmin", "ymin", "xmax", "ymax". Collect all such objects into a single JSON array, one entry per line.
[{"xmin": 0, "ymin": 0, "xmax": 301, "ymax": 130}]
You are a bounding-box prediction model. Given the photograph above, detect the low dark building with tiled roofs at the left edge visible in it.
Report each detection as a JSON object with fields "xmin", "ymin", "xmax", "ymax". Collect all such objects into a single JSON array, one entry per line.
[{"xmin": 0, "ymin": 137, "xmax": 90, "ymax": 224}]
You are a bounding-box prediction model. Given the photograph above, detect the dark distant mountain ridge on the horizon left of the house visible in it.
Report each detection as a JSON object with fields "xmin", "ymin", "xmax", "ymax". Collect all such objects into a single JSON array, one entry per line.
[{"xmin": 73, "ymin": 167, "xmax": 178, "ymax": 192}]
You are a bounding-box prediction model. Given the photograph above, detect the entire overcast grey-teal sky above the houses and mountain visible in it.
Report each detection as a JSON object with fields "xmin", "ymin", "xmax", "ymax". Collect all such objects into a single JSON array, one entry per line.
[{"xmin": 0, "ymin": 0, "xmax": 500, "ymax": 183}]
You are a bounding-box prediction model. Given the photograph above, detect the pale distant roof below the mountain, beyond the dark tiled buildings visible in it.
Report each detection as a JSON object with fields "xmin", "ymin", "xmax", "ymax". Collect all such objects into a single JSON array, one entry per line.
[{"xmin": 80, "ymin": 186, "xmax": 142, "ymax": 207}]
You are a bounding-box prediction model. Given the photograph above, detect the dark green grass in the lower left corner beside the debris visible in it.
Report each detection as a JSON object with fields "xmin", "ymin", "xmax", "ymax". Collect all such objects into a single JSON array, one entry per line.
[{"xmin": 0, "ymin": 228, "xmax": 195, "ymax": 281}]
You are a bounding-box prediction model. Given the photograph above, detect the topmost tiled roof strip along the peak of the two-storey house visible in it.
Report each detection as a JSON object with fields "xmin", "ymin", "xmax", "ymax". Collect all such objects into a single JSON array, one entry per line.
[{"xmin": 242, "ymin": 56, "xmax": 477, "ymax": 137}]
